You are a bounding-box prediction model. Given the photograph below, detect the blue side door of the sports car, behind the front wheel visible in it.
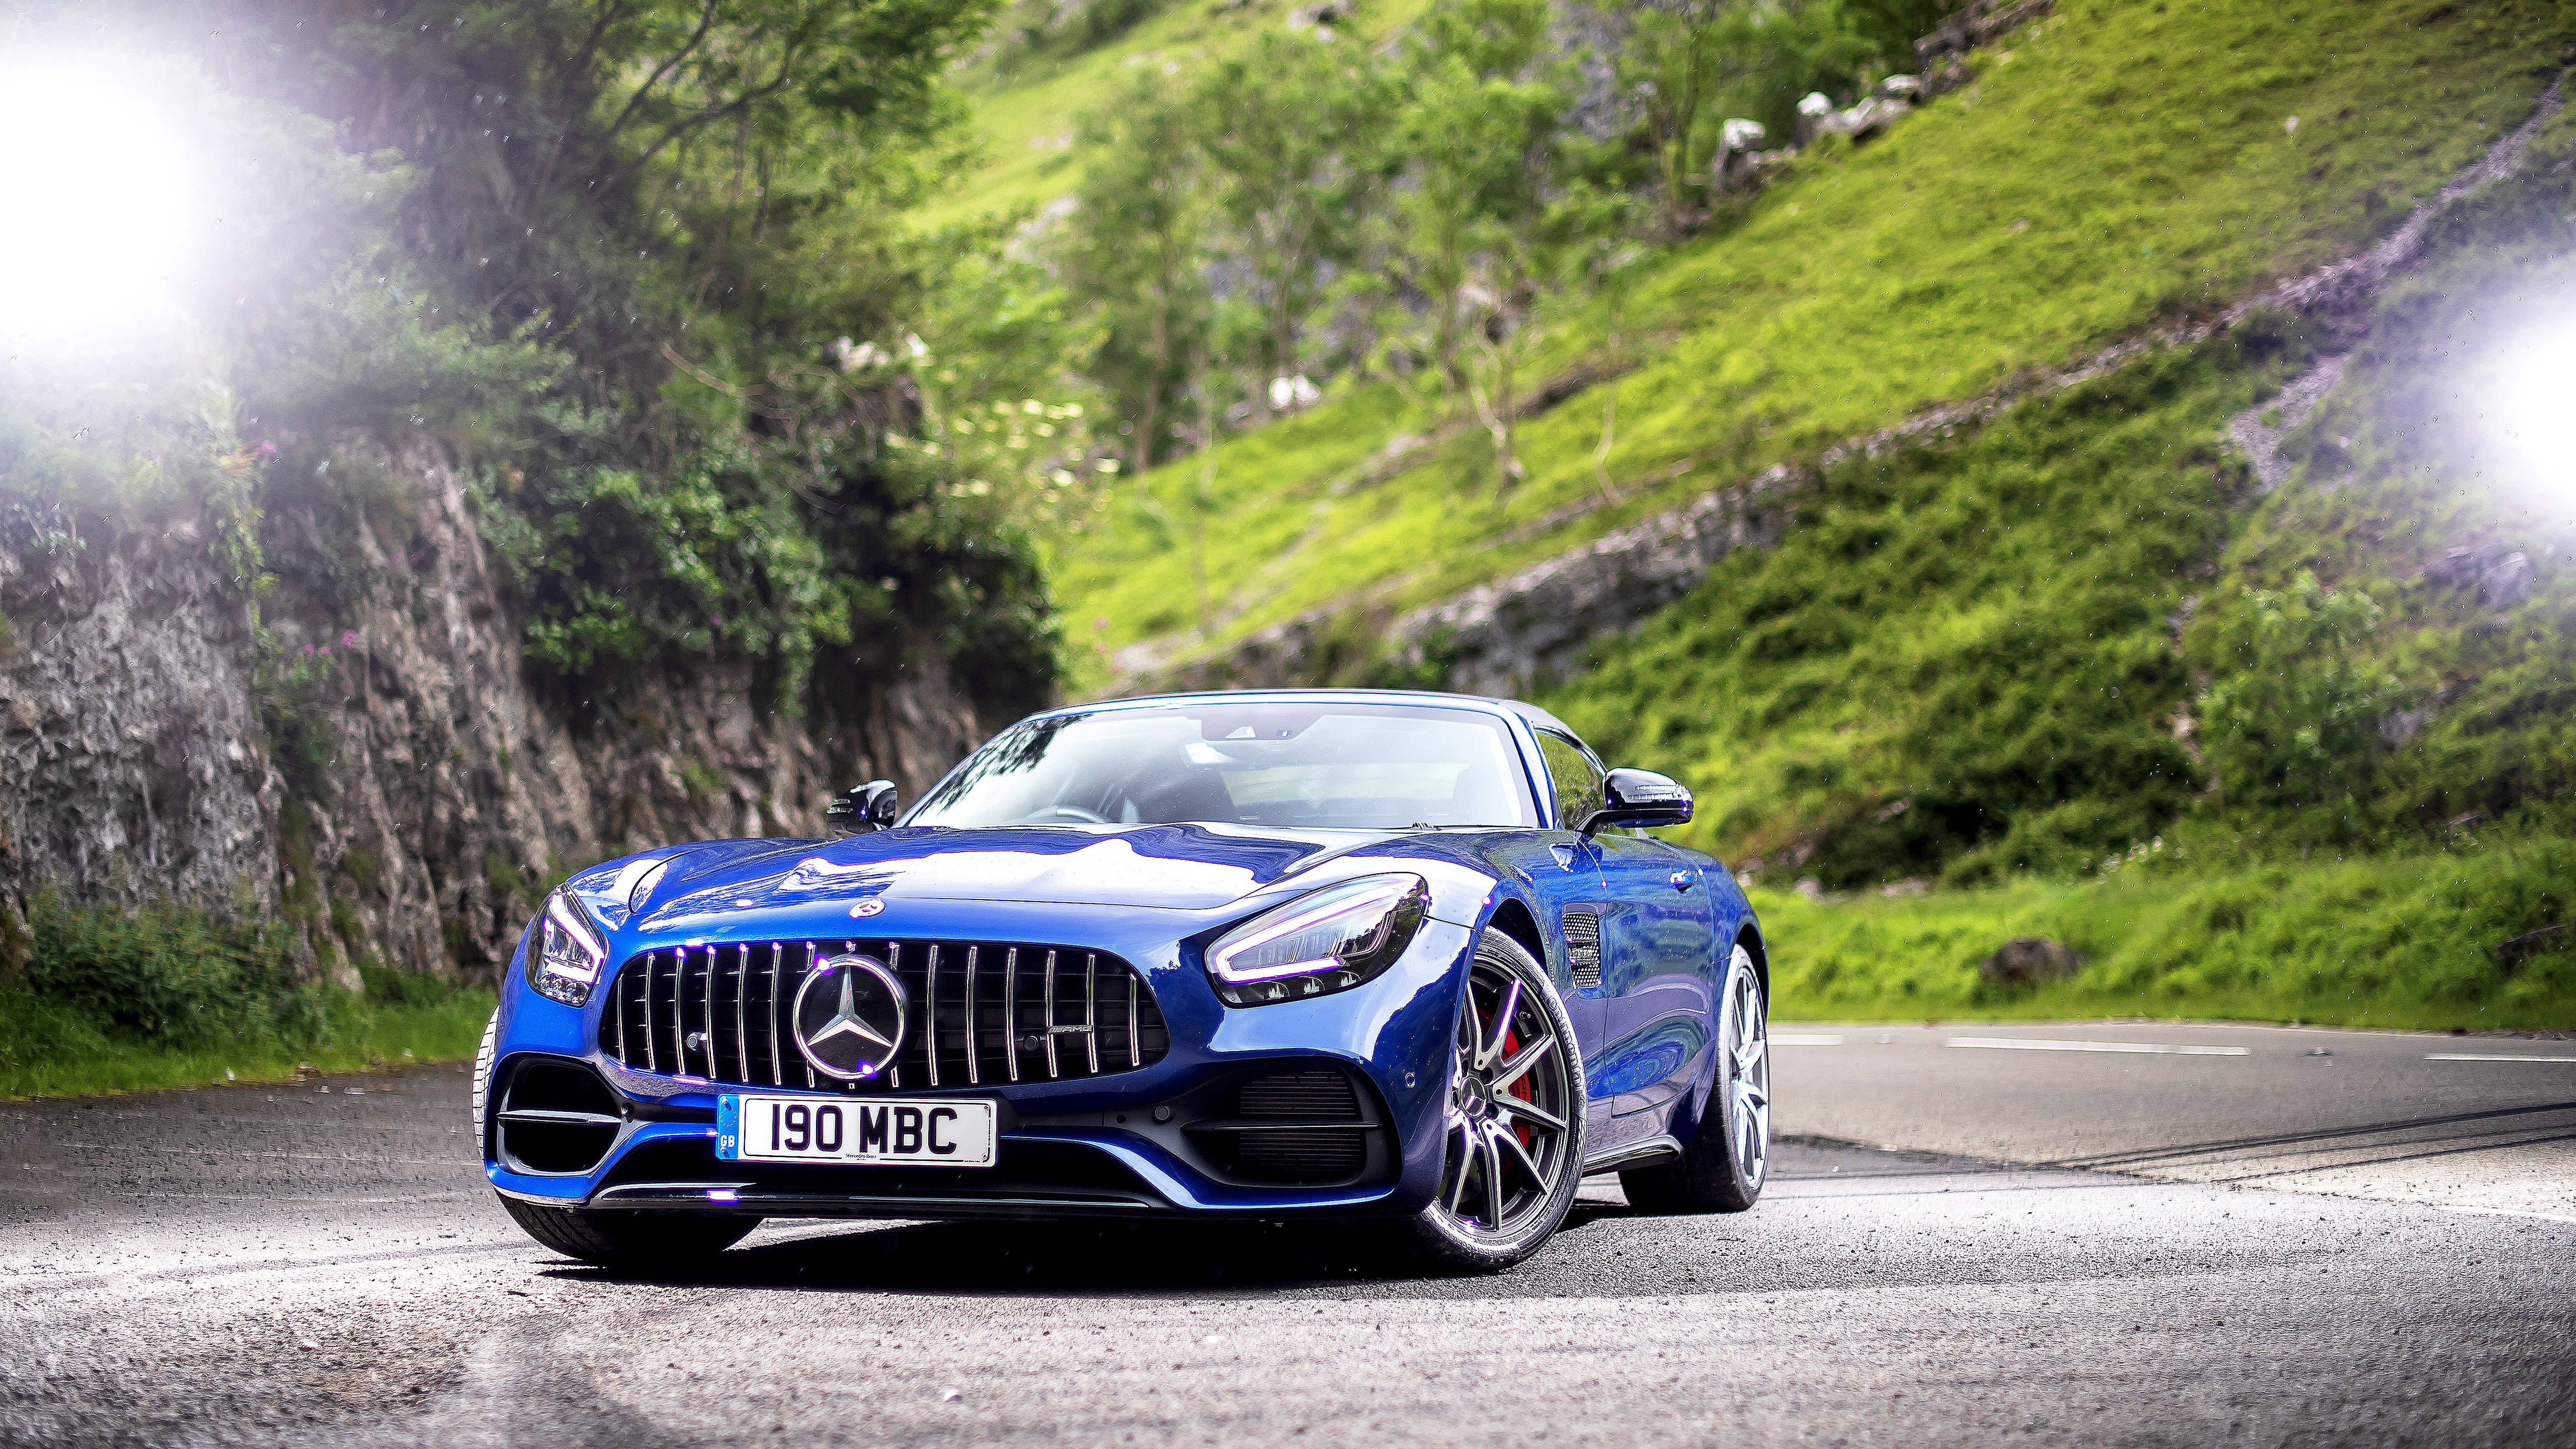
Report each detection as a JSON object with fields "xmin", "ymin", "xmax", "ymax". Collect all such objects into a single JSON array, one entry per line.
[{"xmin": 1541, "ymin": 732, "xmax": 1716, "ymax": 1153}]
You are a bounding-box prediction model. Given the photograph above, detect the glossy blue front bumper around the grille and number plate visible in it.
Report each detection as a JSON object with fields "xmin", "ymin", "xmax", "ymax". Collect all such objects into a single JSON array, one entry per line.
[{"xmin": 481, "ymin": 903, "xmax": 1474, "ymax": 1220}]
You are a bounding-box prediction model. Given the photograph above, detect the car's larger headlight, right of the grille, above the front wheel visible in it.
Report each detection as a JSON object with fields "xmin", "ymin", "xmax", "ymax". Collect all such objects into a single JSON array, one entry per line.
[{"xmin": 1208, "ymin": 876, "xmax": 1432, "ymax": 1006}]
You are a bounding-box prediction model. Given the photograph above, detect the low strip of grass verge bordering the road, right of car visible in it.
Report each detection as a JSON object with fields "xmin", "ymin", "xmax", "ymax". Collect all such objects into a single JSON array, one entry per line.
[{"xmin": 1754, "ymin": 841, "xmax": 2576, "ymax": 1031}]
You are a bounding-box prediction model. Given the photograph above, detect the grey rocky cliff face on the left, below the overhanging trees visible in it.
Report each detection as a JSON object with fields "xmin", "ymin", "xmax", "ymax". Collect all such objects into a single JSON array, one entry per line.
[{"xmin": 0, "ymin": 443, "xmax": 982, "ymax": 985}]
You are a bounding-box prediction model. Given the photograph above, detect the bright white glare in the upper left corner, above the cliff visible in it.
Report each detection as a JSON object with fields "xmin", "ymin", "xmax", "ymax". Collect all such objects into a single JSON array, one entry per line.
[{"xmin": 0, "ymin": 67, "xmax": 193, "ymax": 353}]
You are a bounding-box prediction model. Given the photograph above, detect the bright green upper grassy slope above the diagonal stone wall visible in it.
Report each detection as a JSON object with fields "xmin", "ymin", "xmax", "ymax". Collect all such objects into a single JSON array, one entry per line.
[{"xmin": 1056, "ymin": 0, "xmax": 2571, "ymax": 688}]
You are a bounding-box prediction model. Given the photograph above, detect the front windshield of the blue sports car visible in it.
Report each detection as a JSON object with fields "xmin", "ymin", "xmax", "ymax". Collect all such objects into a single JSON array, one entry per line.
[{"xmin": 909, "ymin": 701, "xmax": 1538, "ymax": 830}]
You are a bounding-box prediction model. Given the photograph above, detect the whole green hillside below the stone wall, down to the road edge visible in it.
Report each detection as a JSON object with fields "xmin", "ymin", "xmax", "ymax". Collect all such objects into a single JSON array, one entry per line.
[{"xmin": 1551, "ymin": 96, "xmax": 2576, "ymax": 1026}]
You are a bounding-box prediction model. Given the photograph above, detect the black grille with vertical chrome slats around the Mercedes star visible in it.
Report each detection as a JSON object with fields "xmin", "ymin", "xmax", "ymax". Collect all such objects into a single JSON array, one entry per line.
[{"xmin": 600, "ymin": 941, "xmax": 1172, "ymax": 1093}]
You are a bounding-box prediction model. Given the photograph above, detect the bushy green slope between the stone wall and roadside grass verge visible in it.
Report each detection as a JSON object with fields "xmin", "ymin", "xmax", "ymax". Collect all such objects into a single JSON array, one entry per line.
[{"xmin": 1551, "ymin": 102, "xmax": 2576, "ymax": 866}]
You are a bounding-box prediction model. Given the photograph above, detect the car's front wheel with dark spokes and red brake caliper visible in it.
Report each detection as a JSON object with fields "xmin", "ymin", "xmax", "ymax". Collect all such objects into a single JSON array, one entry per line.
[{"xmin": 1404, "ymin": 931, "xmax": 1584, "ymax": 1274}]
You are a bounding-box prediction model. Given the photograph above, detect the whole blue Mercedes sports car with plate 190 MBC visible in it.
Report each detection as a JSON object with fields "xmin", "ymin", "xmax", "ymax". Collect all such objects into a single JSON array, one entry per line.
[{"xmin": 474, "ymin": 691, "xmax": 1769, "ymax": 1271}]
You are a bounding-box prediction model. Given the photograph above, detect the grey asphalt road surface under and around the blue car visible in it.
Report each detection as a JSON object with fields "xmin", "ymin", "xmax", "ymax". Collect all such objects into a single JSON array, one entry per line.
[{"xmin": 0, "ymin": 1023, "xmax": 2576, "ymax": 1449}]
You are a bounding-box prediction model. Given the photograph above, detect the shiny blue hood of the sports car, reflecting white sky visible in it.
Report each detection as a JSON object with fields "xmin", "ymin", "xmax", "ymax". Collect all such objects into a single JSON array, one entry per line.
[{"xmin": 641, "ymin": 825, "xmax": 1389, "ymax": 926}]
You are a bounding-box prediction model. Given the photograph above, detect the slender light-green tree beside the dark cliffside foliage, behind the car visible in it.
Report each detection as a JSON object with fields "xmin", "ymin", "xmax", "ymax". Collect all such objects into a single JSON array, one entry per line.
[{"xmin": 1061, "ymin": 69, "xmax": 1208, "ymax": 477}]
